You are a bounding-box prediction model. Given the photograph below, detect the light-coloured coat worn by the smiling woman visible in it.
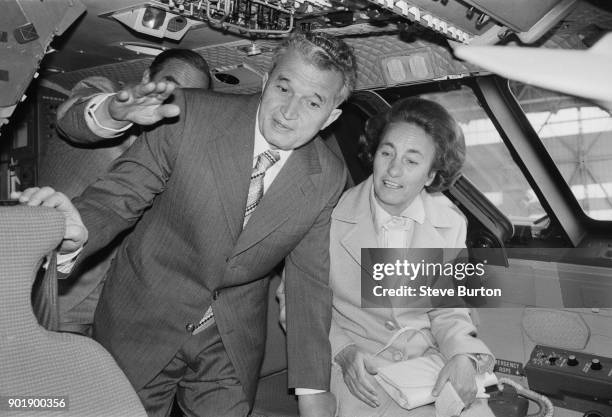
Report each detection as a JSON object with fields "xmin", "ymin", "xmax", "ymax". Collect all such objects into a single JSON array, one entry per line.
[{"xmin": 330, "ymin": 177, "xmax": 490, "ymax": 361}]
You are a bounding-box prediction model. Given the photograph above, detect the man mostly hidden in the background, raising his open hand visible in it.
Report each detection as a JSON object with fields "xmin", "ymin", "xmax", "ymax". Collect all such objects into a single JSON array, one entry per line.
[{"xmin": 38, "ymin": 49, "xmax": 210, "ymax": 336}]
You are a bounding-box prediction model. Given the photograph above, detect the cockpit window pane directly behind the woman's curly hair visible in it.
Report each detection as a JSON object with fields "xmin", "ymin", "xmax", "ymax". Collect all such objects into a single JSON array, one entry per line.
[{"xmin": 421, "ymin": 86, "xmax": 546, "ymax": 226}]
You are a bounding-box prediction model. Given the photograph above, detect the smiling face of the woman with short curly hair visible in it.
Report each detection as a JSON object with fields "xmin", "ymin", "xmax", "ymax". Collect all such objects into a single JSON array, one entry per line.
[{"xmin": 374, "ymin": 122, "xmax": 436, "ymax": 216}]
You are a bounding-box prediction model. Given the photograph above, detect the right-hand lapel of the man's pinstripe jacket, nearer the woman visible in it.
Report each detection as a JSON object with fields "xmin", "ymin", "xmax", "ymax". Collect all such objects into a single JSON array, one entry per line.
[{"xmin": 234, "ymin": 141, "xmax": 321, "ymax": 256}]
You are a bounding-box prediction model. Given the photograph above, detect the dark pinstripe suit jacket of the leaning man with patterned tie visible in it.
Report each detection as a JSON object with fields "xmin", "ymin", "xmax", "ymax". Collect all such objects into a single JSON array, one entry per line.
[{"xmin": 68, "ymin": 90, "xmax": 346, "ymax": 401}]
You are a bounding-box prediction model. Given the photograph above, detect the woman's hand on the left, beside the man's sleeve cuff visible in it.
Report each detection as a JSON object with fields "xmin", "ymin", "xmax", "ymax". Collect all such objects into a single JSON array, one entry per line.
[{"xmin": 334, "ymin": 345, "xmax": 383, "ymax": 407}]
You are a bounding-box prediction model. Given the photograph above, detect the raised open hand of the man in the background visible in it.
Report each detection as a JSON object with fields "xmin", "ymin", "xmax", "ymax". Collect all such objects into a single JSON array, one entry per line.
[{"xmin": 106, "ymin": 81, "xmax": 180, "ymax": 127}]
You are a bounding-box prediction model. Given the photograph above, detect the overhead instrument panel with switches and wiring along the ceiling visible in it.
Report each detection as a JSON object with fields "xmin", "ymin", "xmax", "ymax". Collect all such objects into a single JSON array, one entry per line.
[{"xmin": 102, "ymin": 0, "xmax": 577, "ymax": 44}]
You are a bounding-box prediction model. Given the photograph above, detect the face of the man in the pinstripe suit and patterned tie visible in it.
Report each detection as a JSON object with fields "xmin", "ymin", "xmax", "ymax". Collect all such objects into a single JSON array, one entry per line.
[{"xmin": 259, "ymin": 50, "xmax": 343, "ymax": 150}]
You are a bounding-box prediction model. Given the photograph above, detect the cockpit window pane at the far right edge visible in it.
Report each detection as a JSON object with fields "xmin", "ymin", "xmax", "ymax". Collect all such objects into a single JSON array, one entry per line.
[{"xmin": 510, "ymin": 81, "xmax": 612, "ymax": 220}]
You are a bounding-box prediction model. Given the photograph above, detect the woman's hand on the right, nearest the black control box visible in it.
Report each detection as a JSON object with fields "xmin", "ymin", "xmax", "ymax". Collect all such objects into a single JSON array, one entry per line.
[{"xmin": 431, "ymin": 355, "xmax": 478, "ymax": 407}]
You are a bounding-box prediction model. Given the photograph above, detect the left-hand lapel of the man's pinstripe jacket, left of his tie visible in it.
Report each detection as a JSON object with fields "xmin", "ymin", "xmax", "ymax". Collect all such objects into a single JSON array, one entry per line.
[{"xmin": 209, "ymin": 96, "xmax": 259, "ymax": 241}]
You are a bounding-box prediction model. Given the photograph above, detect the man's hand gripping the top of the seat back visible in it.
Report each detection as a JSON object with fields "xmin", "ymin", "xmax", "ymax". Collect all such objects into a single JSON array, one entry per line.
[{"xmin": 11, "ymin": 187, "xmax": 88, "ymax": 253}]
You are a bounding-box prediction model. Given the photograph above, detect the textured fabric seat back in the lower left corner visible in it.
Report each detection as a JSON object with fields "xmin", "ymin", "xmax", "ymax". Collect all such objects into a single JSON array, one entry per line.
[{"xmin": 0, "ymin": 206, "xmax": 146, "ymax": 417}]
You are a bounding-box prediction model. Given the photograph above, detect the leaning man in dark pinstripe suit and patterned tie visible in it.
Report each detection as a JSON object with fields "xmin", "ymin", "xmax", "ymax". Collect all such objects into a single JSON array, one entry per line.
[{"xmin": 19, "ymin": 34, "xmax": 355, "ymax": 417}]
